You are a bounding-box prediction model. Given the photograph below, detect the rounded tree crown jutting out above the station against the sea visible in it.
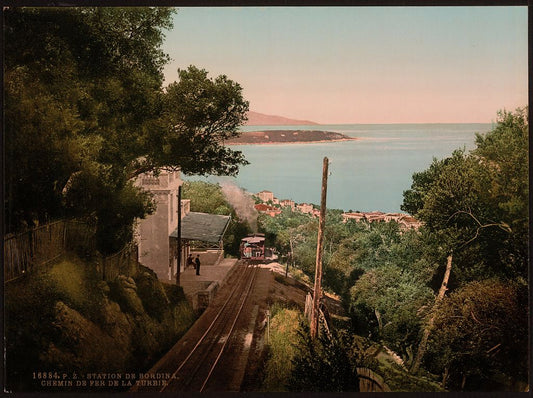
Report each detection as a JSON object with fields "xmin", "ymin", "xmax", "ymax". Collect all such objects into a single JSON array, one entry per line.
[{"xmin": 130, "ymin": 65, "xmax": 248, "ymax": 177}]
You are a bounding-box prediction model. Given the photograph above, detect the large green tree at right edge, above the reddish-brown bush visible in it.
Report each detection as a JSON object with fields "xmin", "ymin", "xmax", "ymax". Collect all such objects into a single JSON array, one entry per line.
[{"xmin": 402, "ymin": 109, "xmax": 529, "ymax": 284}]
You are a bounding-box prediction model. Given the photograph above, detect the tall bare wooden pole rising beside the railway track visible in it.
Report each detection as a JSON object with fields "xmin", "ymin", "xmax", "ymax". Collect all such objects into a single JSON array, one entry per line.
[{"xmin": 311, "ymin": 157, "xmax": 328, "ymax": 338}]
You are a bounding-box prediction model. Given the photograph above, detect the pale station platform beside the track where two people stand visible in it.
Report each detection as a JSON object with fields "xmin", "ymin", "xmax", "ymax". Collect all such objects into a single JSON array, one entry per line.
[{"xmin": 180, "ymin": 252, "xmax": 238, "ymax": 310}]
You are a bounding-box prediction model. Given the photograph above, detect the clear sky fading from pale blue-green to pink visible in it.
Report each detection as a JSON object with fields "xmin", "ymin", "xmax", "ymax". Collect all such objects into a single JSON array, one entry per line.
[{"xmin": 163, "ymin": 6, "xmax": 528, "ymax": 124}]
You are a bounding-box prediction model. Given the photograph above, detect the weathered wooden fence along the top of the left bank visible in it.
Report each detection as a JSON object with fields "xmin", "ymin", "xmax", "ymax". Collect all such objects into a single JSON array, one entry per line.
[{"xmin": 4, "ymin": 220, "xmax": 139, "ymax": 283}]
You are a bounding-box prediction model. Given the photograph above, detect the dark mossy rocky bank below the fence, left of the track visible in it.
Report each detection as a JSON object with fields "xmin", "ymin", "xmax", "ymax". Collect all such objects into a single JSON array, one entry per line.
[{"xmin": 5, "ymin": 256, "xmax": 195, "ymax": 392}]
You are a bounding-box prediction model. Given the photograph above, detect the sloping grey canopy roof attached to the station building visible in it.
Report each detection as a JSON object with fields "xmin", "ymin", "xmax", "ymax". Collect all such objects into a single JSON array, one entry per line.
[{"xmin": 170, "ymin": 212, "xmax": 231, "ymax": 243}]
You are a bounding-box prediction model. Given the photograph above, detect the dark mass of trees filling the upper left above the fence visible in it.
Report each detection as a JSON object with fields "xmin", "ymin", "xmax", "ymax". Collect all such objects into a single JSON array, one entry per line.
[{"xmin": 4, "ymin": 7, "xmax": 248, "ymax": 253}]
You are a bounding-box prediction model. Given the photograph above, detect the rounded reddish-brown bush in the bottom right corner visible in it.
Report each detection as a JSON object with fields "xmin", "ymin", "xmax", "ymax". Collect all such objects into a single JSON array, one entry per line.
[{"xmin": 427, "ymin": 279, "xmax": 528, "ymax": 390}]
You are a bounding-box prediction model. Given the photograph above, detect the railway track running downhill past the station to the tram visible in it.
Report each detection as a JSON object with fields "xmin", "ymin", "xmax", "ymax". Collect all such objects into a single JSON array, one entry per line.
[{"xmin": 134, "ymin": 263, "xmax": 258, "ymax": 392}]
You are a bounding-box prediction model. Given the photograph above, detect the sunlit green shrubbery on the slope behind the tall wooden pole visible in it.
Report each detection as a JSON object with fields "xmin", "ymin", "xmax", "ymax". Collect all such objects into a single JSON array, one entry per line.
[{"xmin": 260, "ymin": 210, "xmax": 438, "ymax": 356}]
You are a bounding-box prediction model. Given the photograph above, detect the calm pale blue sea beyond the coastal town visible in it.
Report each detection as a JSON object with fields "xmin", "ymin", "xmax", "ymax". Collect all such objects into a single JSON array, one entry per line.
[{"xmin": 184, "ymin": 123, "xmax": 494, "ymax": 212}]
